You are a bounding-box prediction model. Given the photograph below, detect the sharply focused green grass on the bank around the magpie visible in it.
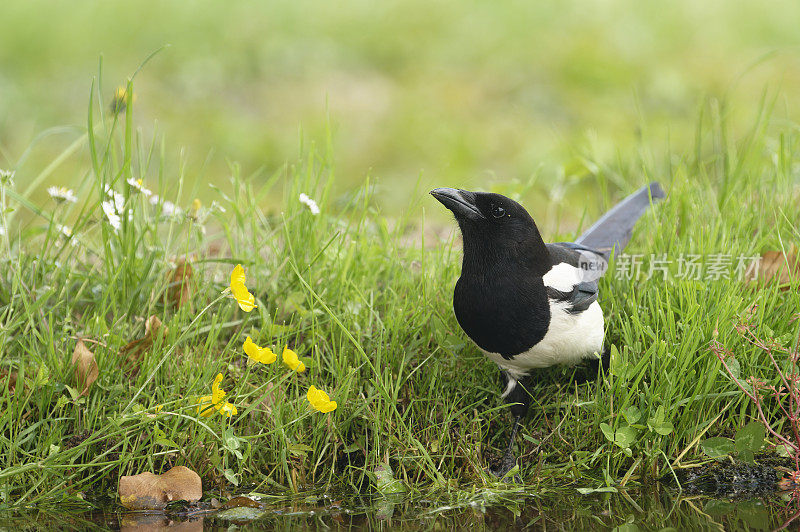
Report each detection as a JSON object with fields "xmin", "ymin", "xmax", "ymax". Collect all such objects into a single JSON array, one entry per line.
[{"xmin": 0, "ymin": 78, "xmax": 800, "ymax": 505}]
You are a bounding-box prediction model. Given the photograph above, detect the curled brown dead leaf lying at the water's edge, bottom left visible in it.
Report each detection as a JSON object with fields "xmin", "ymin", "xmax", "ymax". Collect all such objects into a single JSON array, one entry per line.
[{"xmin": 119, "ymin": 466, "xmax": 203, "ymax": 510}]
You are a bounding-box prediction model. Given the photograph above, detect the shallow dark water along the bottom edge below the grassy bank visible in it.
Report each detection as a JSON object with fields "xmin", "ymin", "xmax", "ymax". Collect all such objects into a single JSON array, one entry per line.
[{"xmin": 0, "ymin": 486, "xmax": 800, "ymax": 531}]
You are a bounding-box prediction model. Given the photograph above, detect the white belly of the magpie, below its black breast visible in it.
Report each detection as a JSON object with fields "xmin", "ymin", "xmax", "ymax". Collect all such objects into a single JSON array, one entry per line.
[{"xmin": 484, "ymin": 300, "xmax": 604, "ymax": 379}]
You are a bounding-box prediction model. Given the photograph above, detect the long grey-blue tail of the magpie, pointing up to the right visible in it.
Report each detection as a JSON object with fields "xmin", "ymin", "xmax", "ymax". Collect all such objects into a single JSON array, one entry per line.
[{"xmin": 575, "ymin": 182, "xmax": 666, "ymax": 259}]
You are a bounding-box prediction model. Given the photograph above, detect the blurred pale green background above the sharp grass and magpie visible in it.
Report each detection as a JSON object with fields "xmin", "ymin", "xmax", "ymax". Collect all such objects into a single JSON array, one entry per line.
[{"xmin": 0, "ymin": 0, "xmax": 800, "ymax": 224}]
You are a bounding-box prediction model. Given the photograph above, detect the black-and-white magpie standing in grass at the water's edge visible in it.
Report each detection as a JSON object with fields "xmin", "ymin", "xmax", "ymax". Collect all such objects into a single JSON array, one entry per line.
[{"xmin": 430, "ymin": 182, "xmax": 664, "ymax": 476}]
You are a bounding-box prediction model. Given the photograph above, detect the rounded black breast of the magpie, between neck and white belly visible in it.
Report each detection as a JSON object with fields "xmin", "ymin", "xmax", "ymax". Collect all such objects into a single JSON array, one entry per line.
[{"xmin": 453, "ymin": 275, "xmax": 550, "ymax": 359}]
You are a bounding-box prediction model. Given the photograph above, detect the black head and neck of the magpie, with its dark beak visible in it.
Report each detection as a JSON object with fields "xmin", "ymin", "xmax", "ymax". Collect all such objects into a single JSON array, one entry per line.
[{"xmin": 431, "ymin": 188, "xmax": 551, "ymax": 272}]
